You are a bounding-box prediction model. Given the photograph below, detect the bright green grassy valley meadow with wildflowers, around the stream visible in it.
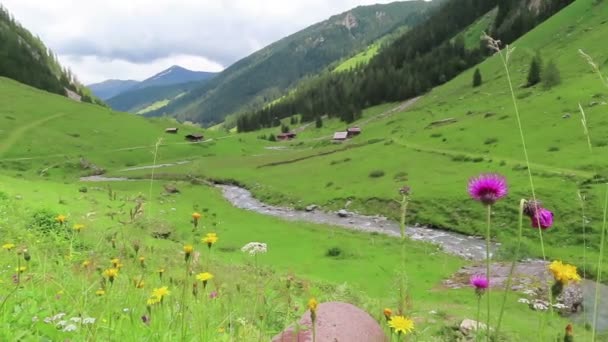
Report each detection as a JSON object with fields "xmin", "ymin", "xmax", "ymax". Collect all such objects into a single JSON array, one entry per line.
[{"xmin": 0, "ymin": 1, "xmax": 608, "ymax": 341}]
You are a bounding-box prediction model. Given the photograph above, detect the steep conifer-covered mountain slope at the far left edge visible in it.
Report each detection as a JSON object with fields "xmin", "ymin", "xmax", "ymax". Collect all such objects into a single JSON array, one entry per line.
[{"xmin": 0, "ymin": 5, "xmax": 102, "ymax": 104}]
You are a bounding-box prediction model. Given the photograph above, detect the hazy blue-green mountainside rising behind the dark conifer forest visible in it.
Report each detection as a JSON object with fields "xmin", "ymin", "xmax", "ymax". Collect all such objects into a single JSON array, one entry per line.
[{"xmin": 149, "ymin": 1, "xmax": 439, "ymax": 124}]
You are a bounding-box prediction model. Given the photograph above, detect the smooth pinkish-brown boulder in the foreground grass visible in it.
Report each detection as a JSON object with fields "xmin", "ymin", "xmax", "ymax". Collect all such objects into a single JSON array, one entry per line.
[{"xmin": 272, "ymin": 302, "xmax": 388, "ymax": 342}]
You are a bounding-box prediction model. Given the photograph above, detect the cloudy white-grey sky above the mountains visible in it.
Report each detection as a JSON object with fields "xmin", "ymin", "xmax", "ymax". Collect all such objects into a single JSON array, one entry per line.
[{"xmin": 0, "ymin": 0, "xmax": 408, "ymax": 84}]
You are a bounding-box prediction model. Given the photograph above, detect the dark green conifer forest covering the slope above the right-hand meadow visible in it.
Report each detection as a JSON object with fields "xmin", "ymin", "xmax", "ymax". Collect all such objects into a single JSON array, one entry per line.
[{"xmin": 237, "ymin": 0, "xmax": 572, "ymax": 132}]
